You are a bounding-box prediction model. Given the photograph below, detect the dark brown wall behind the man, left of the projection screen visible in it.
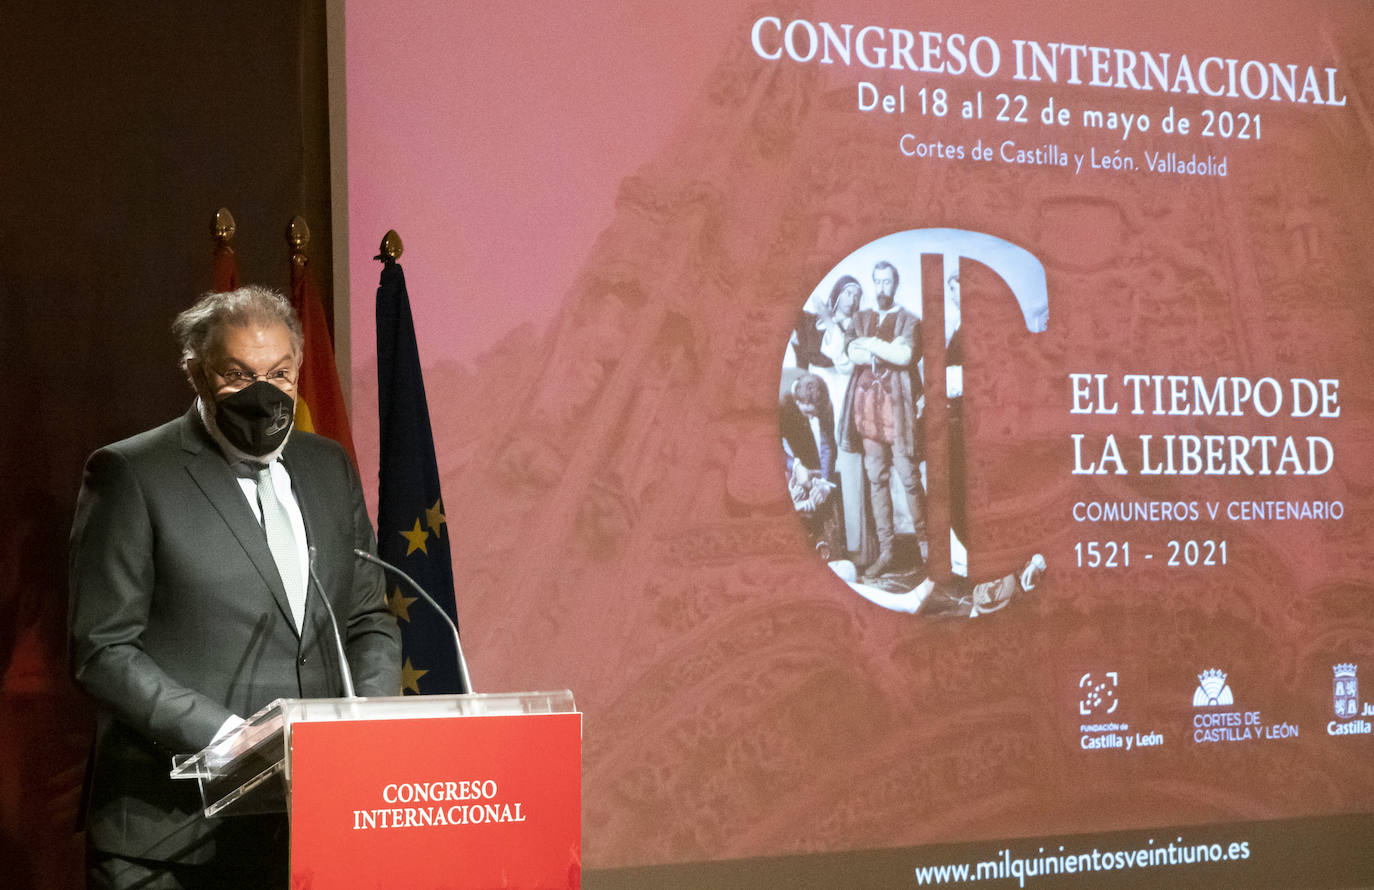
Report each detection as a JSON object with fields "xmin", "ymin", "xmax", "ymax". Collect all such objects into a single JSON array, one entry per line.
[{"xmin": 0, "ymin": 0, "xmax": 330, "ymax": 887}]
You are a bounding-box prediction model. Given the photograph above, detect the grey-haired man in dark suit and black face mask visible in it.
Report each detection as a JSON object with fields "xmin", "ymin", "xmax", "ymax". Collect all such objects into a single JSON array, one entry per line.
[{"xmin": 69, "ymin": 286, "xmax": 400, "ymax": 887}]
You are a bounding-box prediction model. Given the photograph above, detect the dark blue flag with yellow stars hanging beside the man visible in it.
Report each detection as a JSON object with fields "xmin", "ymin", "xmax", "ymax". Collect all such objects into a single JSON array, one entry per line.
[{"xmin": 376, "ymin": 255, "xmax": 467, "ymax": 695}]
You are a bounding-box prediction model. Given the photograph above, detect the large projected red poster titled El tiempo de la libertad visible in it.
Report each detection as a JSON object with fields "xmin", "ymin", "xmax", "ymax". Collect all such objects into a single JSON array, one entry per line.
[{"xmin": 348, "ymin": 3, "xmax": 1374, "ymax": 887}]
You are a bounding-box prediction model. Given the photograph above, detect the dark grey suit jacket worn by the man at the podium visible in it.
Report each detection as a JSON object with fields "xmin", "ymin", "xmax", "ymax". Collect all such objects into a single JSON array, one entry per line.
[{"xmin": 69, "ymin": 408, "xmax": 400, "ymax": 863}]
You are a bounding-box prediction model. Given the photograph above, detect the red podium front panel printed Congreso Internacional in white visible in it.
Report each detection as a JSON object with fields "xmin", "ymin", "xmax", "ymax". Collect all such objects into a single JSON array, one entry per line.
[{"xmin": 289, "ymin": 713, "xmax": 581, "ymax": 890}]
